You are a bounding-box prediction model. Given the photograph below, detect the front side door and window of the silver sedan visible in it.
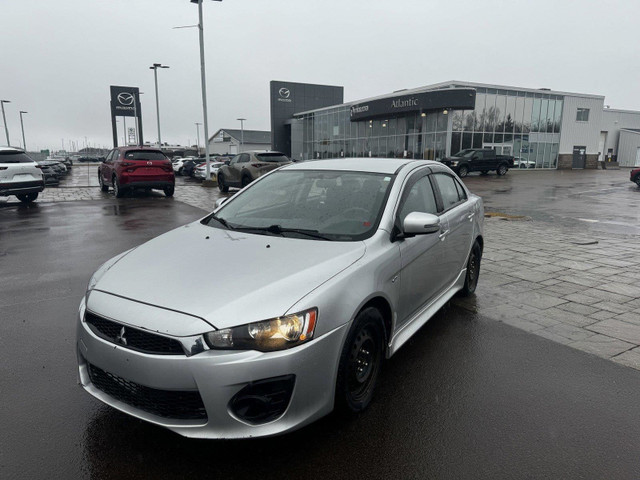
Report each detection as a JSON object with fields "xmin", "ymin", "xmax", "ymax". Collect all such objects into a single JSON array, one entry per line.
[{"xmin": 396, "ymin": 171, "xmax": 448, "ymax": 328}]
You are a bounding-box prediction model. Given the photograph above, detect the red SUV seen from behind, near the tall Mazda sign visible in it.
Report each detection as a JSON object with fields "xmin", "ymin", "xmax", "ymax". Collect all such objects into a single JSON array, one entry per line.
[{"xmin": 98, "ymin": 147, "xmax": 176, "ymax": 198}]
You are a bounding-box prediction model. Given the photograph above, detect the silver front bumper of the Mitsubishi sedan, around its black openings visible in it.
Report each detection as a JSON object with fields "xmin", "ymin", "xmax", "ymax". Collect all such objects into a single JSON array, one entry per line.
[{"xmin": 77, "ymin": 300, "xmax": 347, "ymax": 438}]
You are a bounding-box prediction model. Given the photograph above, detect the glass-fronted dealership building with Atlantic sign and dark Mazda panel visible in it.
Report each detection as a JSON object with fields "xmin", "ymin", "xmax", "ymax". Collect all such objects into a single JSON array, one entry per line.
[{"xmin": 270, "ymin": 81, "xmax": 640, "ymax": 169}]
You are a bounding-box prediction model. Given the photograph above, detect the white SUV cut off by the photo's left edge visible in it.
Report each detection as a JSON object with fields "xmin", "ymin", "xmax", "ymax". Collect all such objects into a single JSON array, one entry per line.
[{"xmin": 0, "ymin": 147, "xmax": 44, "ymax": 203}]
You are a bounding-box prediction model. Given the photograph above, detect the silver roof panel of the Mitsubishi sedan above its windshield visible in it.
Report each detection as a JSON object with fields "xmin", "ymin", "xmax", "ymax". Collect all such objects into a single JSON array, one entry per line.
[{"xmin": 283, "ymin": 157, "xmax": 440, "ymax": 174}]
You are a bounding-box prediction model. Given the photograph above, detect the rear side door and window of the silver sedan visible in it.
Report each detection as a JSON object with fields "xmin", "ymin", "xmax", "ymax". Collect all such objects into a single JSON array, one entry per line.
[{"xmin": 432, "ymin": 172, "xmax": 476, "ymax": 284}]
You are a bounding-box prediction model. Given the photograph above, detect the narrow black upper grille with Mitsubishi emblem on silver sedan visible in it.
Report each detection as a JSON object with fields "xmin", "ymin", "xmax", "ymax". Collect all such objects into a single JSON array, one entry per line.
[{"xmin": 84, "ymin": 312, "xmax": 185, "ymax": 355}]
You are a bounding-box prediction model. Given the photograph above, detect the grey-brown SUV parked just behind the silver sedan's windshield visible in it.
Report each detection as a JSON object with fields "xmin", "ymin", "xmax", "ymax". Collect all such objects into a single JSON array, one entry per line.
[{"xmin": 218, "ymin": 150, "xmax": 291, "ymax": 192}]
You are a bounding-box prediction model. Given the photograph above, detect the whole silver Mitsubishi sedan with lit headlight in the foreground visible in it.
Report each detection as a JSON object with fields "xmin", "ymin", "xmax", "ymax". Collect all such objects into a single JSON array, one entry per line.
[{"xmin": 76, "ymin": 158, "xmax": 484, "ymax": 438}]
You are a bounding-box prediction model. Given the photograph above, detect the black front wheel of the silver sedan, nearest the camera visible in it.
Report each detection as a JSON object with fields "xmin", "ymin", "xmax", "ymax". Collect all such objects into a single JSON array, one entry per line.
[{"xmin": 335, "ymin": 307, "xmax": 385, "ymax": 413}]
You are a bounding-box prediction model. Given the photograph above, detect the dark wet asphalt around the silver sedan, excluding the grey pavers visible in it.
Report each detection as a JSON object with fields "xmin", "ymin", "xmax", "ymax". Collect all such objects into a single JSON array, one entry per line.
[{"xmin": 0, "ymin": 181, "xmax": 640, "ymax": 480}]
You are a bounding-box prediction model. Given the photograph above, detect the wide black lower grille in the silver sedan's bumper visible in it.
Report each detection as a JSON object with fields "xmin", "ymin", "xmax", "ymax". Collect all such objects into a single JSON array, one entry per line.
[{"xmin": 87, "ymin": 363, "xmax": 207, "ymax": 420}]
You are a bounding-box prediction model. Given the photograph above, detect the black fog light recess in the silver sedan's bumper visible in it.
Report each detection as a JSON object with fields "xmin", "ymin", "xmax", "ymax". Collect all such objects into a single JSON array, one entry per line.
[{"xmin": 229, "ymin": 375, "xmax": 296, "ymax": 425}]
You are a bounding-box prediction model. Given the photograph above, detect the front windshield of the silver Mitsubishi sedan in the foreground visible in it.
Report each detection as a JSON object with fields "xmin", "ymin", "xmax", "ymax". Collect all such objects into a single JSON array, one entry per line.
[{"xmin": 202, "ymin": 170, "xmax": 393, "ymax": 241}]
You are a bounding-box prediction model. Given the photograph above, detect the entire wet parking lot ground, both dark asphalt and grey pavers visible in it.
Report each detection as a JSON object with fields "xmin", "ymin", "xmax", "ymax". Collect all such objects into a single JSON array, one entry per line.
[{"xmin": 0, "ymin": 166, "xmax": 640, "ymax": 479}]
